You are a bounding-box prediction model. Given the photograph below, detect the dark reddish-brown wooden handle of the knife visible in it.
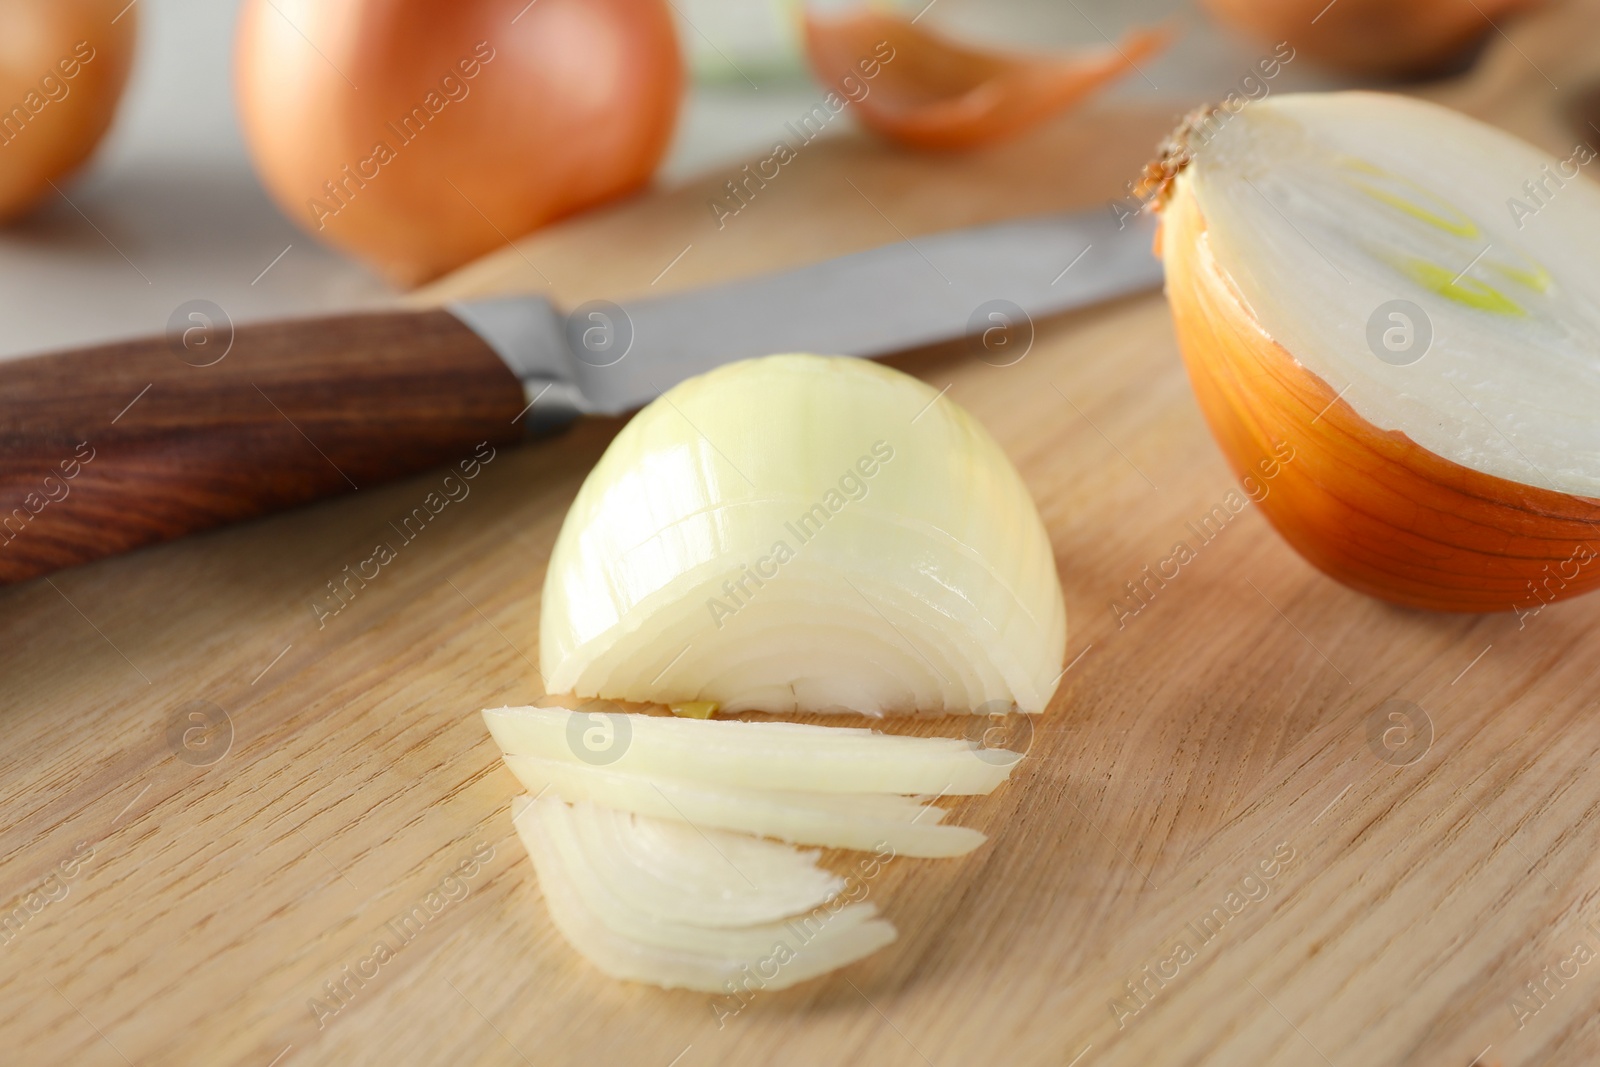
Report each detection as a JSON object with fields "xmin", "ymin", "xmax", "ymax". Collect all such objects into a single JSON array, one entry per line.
[{"xmin": 0, "ymin": 310, "xmax": 525, "ymax": 582}]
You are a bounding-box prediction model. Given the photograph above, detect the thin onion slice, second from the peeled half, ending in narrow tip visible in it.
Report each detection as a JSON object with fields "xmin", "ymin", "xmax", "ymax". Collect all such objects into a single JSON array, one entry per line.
[{"xmin": 506, "ymin": 755, "xmax": 986, "ymax": 857}]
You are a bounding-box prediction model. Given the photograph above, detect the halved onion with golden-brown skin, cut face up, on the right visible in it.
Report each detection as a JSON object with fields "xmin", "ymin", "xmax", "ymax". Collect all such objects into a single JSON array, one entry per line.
[{"xmin": 1155, "ymin": 93, "xmax": 1600, "ymax": 611}]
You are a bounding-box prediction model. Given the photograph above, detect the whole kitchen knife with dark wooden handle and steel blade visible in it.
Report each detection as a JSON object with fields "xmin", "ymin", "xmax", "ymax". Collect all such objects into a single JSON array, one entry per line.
[{"xmin": 0, "ymin": 211, "xmax": 1162, "ymax": 584}]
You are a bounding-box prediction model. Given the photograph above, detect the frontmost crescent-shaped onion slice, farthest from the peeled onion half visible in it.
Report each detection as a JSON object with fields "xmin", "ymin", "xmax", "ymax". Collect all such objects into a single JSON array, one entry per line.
[{"xmin": 514, "ymin": 797, "xmax": 896, "ymax": 993}]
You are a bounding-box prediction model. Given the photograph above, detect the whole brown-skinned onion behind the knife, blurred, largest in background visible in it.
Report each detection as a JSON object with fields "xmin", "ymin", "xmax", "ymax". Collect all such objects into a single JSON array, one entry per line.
[{"xmin": 237, "ymin": 0, "xmax": 683, "ymax": 283}]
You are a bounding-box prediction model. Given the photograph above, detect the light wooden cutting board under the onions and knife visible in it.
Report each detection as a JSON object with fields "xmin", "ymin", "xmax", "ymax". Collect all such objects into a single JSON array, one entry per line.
[{"xmin": 9, "ymin": 11, "xmax": 1600, "ymax": 1067}]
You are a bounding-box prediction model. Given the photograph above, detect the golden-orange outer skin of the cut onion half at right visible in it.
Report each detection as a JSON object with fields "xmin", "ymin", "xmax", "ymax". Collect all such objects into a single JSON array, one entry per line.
[{"xmin": 1157, "ymin": 154, "xmax": 1600, "ymax": 613}]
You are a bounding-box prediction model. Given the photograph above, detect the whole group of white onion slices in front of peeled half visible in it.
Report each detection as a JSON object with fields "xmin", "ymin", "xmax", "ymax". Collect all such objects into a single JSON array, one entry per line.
[{"xmin": 483, "ymin": 705, "xmax": 1021, "ymax": 992}]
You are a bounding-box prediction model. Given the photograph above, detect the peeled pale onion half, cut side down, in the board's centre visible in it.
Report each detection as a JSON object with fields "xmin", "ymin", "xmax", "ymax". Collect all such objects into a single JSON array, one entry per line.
[{"xmin": 539, "ymin": 355, "xmax": 1066, "ymax": 715}]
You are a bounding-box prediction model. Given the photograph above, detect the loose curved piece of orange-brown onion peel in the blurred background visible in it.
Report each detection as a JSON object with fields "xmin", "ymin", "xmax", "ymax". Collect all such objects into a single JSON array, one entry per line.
[{"xmin": 805, "ymin": 8, "xmax": 1171, "ymax": 149}]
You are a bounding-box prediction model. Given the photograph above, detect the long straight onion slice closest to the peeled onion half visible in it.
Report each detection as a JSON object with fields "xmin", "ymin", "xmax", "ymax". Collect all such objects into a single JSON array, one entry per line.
[{"xmin": 483, "ymin": 707, "xmax": 1022, "ymax": 797}]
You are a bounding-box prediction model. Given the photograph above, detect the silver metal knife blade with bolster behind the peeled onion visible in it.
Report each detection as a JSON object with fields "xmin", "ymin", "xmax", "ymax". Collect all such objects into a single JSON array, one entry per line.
[{"xmin": 448, "ymin": 211, "xmax": 1162, "ymax": 427}]
